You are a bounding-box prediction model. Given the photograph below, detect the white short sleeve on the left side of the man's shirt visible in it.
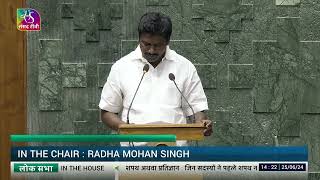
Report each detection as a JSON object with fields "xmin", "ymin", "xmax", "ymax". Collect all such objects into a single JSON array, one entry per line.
[{"xmin": 99, "ymin": 63, "xmax": 123, "ymax": 113}]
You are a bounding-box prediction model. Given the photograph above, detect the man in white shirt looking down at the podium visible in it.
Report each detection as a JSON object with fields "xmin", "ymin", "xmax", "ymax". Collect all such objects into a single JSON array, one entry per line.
[{"xmin": 99, "ymin": 12, "xmax": 212, "ymax": 145}]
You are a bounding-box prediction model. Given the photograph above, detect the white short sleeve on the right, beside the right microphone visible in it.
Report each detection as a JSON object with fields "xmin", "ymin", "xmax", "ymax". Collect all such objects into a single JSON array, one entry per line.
[{"xmin": 182, "ymin": 64, "xmax": 208, "ymax": 116}]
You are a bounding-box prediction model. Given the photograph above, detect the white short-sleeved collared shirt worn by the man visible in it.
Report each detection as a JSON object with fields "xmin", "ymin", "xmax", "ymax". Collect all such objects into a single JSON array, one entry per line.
[{"xmin": 99, "ymin": 46, "xmax": 208, "ymax": 146}]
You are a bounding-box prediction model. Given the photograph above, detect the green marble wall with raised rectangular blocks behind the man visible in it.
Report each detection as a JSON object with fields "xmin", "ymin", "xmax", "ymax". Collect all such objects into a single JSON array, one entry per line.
[{"xmin": 27, "ymin": 0, "xmax": 320, "ymax": 177}]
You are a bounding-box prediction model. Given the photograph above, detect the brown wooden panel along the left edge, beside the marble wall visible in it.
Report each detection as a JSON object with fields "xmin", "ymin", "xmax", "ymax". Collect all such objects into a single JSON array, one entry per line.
[{"xmin": 0, "ymin": 0, "xmax": 27, "ymax": 179}]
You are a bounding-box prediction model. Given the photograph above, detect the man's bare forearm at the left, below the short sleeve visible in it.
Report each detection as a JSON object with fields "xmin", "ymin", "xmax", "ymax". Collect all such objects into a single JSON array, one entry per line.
[{"xmin": 101, "ymin": 110, "xmax": 125, "ymax": 131}]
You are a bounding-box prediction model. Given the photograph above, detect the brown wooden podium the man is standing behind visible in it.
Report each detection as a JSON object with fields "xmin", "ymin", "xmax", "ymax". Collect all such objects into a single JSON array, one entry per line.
[{"xmin": 119, "ymin": 123, "xmax": 205, "ymax": 146}]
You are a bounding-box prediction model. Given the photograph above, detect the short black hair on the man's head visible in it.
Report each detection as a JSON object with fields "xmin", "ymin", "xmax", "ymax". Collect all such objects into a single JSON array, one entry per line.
[{"xmin": 138, "ymin": 12, "xmax": 172, "ymax": 43}]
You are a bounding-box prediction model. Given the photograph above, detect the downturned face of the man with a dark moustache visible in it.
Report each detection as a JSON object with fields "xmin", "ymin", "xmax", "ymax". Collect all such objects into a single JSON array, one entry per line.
[{"xmin": 139, "ymin": 33, "xmax": 167, "ymax": 63}]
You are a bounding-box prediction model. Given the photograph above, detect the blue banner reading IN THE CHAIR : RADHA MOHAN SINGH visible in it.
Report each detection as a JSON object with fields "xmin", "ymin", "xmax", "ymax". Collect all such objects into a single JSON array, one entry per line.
[{"xmin": 11, "ymin": 146, "xmax": 308, "ymax": 162}]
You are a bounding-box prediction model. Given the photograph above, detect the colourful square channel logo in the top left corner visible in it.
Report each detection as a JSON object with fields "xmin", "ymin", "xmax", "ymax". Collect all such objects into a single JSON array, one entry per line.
[{"xmin": 17, "ymin": 8, "xmax": 41, "ymax": 31}]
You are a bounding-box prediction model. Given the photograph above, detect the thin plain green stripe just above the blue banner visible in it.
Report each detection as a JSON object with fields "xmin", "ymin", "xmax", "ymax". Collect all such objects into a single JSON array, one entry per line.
[{"xmin": 10, "ymin": 134, "xmax": 176, "ymax": 142}]
